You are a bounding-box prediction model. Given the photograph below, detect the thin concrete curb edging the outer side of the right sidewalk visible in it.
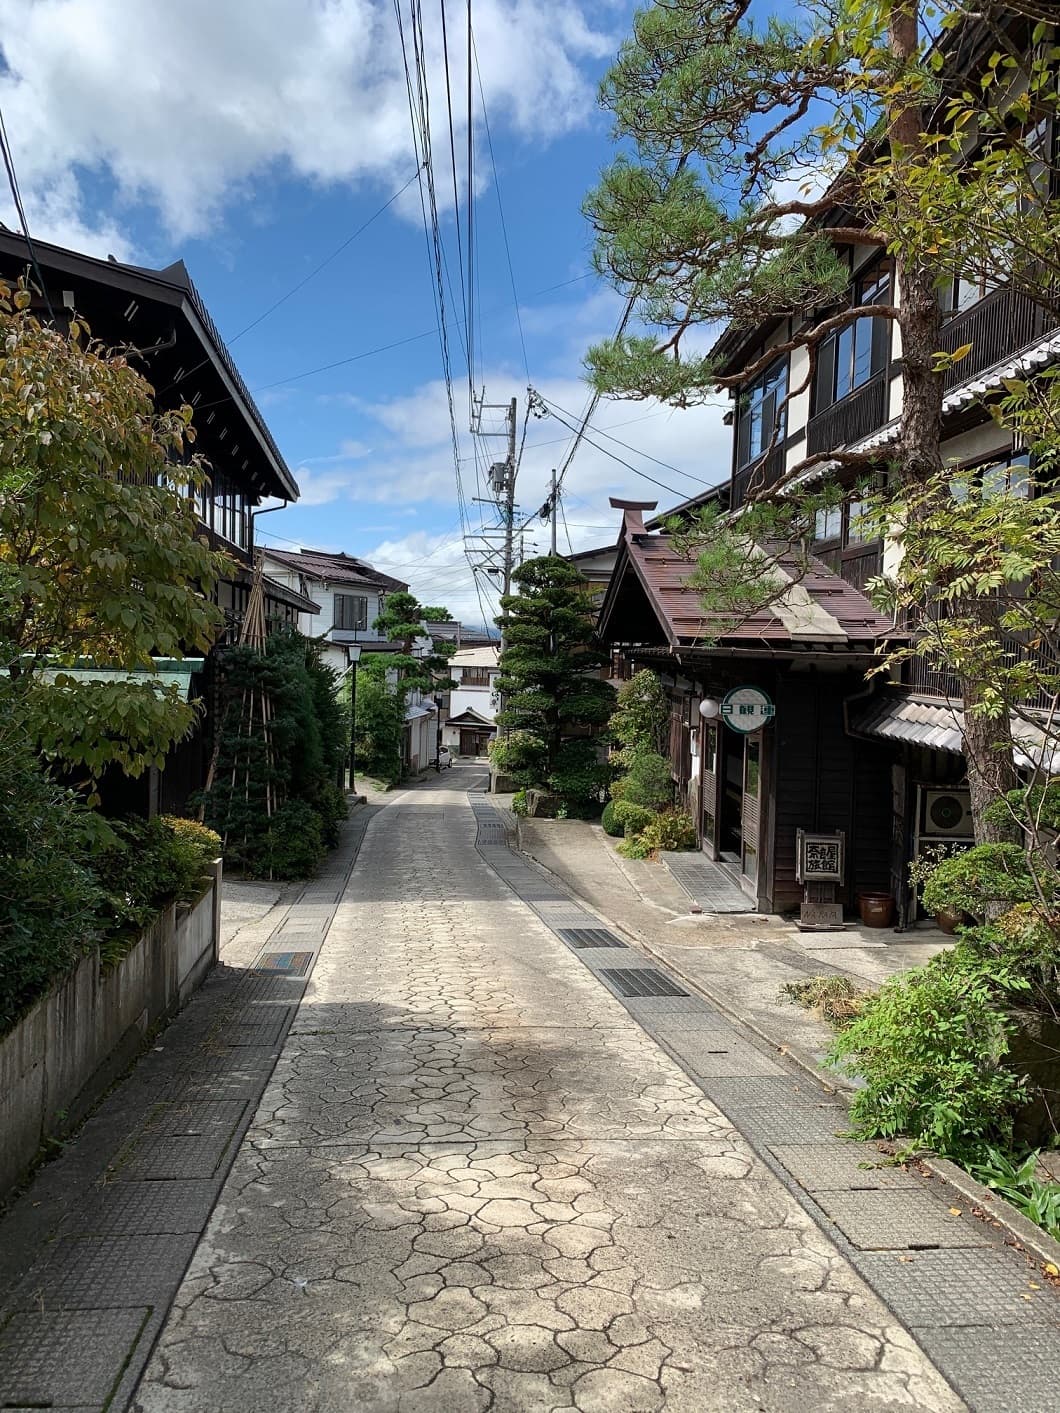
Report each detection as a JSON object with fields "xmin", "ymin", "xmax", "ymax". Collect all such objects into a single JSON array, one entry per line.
[{"xmin": 514, "ymin": 817, "xmax": 1060, "ymax": 1288}]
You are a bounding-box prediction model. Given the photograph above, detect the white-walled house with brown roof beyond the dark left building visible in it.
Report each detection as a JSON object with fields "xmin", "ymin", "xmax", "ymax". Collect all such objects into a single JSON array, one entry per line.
[{"xmin": 263, "ymin": 545, "xmax": 408, "ymax": 671}]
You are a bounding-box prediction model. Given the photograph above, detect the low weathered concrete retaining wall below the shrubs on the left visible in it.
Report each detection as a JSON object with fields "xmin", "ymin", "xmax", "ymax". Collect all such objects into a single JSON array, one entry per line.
[{"xmin": 0, "ymin": 859, "xmax": 220, "ymax": 1200}]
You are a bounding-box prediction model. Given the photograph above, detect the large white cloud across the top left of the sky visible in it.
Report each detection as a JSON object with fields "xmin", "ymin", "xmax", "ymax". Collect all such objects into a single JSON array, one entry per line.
[{"xmin": 0, "ymin": 0, "xmax": 618, "ymax": 245}]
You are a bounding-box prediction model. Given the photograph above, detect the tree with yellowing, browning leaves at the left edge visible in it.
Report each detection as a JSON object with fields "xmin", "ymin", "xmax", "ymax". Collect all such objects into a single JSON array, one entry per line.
[{"xmin": 0, "ymin": 285, "xmax": 226, "ymax": 776}]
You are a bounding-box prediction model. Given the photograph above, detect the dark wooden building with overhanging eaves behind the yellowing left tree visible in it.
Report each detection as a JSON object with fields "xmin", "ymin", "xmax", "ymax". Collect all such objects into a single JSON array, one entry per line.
[{"xmin": 0, "ymin": 226, "xmax": 315, "ymax": 814}]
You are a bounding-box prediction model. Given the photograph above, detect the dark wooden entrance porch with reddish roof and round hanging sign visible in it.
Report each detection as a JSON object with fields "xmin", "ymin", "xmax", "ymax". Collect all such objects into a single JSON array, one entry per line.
[{"xmin": 599, "ymin": 500, "xmax": 895, "ymax": 913}]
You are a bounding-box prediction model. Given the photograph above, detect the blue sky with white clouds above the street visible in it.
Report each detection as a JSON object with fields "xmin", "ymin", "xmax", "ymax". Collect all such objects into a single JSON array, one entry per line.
[{"xmin": 0, "ymin": 0, "xmax": 729, "ymax": 623}]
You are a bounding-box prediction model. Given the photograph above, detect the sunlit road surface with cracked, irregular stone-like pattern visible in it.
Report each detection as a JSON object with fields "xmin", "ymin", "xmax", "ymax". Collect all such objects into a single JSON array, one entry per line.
[{"xmin": 134, "ymin": 770, "xmax": 964, "ymax": 1413}]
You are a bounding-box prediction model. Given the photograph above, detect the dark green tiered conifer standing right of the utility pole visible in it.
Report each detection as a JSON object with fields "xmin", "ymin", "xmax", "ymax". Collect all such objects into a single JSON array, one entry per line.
[{"xmin": 495, "ymin": 555, "xmax": 615, "ymax": 798}]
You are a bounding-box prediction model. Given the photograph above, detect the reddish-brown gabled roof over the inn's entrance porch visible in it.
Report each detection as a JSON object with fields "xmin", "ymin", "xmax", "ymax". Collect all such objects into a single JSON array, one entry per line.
[{"xmin": 599, "ymin": 500, "xmax": 900, "ymax": 657}]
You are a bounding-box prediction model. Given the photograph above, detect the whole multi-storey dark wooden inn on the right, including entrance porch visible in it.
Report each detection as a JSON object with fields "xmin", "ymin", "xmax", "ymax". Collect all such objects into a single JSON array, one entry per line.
[{"xmin": 599, "ymin": 19, "xmax": 1060, "ymax": 924}]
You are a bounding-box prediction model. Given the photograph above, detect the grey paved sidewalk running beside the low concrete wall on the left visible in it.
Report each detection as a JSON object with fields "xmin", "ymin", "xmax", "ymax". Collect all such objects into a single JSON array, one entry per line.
[{"xmin": 0, "ymin": 811, "xmax": 369, "ymax": 1413}]
